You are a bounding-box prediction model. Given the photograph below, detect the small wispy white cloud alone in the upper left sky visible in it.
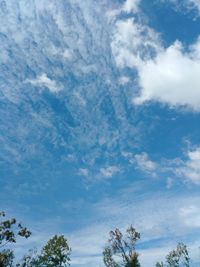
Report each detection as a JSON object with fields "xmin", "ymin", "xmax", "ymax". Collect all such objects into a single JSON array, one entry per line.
[{"xmin": 26, "ymin": 73, "xmax": 62, "ymax": 93}]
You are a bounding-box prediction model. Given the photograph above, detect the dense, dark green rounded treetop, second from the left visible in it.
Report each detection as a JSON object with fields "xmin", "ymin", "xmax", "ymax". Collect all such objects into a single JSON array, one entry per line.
[{"xmin": 35, "ymin": 235, "xmax": 71, "ymax": 267}]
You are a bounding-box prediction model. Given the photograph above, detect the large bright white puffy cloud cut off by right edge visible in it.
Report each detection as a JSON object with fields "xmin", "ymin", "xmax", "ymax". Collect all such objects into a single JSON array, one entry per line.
[{"xmin": 134, "ymin": 39, "xmax": 200, "ymax": 111}]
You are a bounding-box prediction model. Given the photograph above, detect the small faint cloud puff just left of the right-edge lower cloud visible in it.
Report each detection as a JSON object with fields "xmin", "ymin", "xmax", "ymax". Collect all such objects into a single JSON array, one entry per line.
[{"xmin": 134, "ymin": 152, "xmax": 157, "ymax": 172}]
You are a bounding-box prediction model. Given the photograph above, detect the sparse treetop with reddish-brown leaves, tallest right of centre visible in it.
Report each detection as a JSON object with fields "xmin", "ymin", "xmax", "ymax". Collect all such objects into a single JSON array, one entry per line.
[{"xmin": 103, "ymin": 225, "xmax": 140, "ymax": 267}]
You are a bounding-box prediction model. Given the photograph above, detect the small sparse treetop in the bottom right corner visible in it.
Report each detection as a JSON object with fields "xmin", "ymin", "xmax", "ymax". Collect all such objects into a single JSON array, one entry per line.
[{"xmin": 156, "ymin": 243, "xmax": 190, "ymax": 267}]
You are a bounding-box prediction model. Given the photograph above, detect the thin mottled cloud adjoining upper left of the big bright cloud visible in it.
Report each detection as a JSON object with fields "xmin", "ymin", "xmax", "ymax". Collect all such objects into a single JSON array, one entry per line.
[{"xmin": 111, "ymin": 18, "xmax": 159, "ymax": 68}]
